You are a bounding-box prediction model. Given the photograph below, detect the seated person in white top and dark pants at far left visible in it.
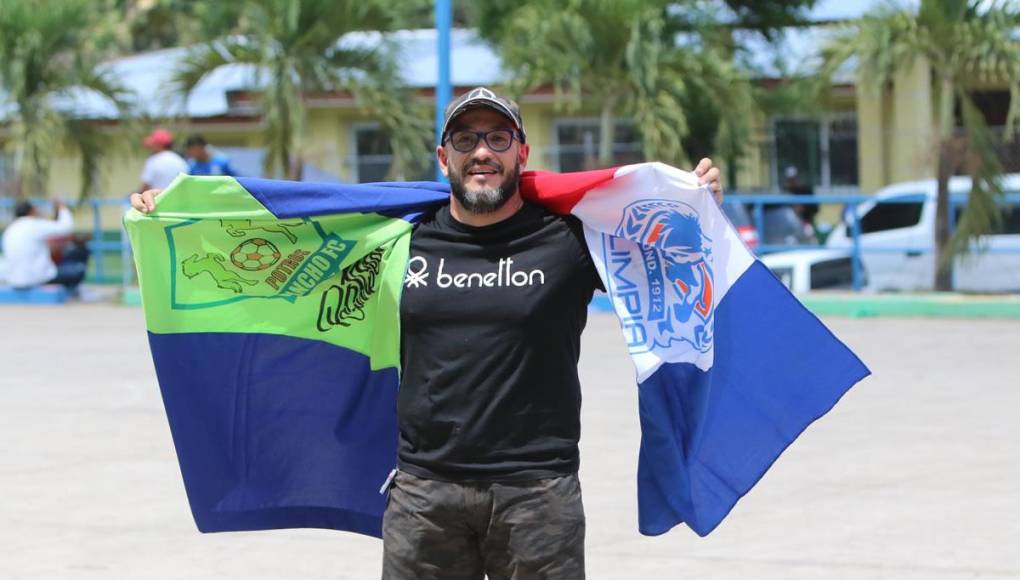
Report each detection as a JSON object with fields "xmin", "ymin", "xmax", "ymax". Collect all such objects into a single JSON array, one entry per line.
[{"xmin": 0, "ymin": 201, "xmax": 89, "ymax": 289}]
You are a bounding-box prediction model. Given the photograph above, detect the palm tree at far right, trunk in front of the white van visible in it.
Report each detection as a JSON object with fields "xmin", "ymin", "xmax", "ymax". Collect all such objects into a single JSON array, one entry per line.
[{"xmin": 820, "ymin": 0, "xmax": 1020, "ymax": 291}]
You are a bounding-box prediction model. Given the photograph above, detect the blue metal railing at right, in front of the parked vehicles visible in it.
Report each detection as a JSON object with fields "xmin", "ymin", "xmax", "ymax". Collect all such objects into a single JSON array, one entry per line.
[{"xmin": 726, "ymin": 193, "xmax": 1020, "ymax": 291}]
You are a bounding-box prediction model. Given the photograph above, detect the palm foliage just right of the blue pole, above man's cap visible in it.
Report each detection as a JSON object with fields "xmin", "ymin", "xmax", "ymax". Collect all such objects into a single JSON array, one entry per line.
[{"xmin": 479, "ymin": 0, "xmax": 750, "ymax": 165}]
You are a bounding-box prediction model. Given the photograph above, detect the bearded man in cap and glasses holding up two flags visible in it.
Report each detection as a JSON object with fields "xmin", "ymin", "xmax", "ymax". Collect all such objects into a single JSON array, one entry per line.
[{"xmin": 132, "ymin": 88, "xmax": 722, "ymax": 580}]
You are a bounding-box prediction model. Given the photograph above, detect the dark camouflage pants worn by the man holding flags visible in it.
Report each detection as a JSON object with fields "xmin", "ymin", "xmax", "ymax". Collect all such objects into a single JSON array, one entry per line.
[{"xmin": 383, "ymin": 472, "xmax": 584, "ymax": 580}]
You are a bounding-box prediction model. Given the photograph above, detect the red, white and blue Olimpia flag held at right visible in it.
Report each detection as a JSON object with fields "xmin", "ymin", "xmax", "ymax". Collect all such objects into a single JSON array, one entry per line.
[{"xmin": 524, "ymin": 163, "xmax": 869, "ymax": 536}]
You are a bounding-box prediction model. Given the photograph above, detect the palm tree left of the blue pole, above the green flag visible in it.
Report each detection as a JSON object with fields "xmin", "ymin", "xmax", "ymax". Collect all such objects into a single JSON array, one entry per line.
[{"xmin": 175, "ymin": 0, "xmax": 431, "ymax": 178}]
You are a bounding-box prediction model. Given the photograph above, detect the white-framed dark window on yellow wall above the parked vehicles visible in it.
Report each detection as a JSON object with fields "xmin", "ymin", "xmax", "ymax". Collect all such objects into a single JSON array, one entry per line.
[{"xmin": 771, "ymin": 113, "xmax": 859, "ymax": 192}]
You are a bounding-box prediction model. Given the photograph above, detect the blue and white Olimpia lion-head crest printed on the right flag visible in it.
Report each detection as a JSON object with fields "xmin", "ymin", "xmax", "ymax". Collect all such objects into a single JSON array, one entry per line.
[{"xmin": 603, "ymin": 200, "xmax": 715, "ymax": 354}]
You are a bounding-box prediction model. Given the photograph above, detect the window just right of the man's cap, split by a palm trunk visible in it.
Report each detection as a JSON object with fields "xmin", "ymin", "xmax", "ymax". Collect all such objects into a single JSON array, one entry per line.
[{"xmin": 552, "ymin": 118, "xmax": 644, "ymax": 171}]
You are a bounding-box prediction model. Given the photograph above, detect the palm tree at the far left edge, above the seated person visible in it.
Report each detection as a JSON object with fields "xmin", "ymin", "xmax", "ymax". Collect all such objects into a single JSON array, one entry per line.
[{"xmin": 0, "ymin": 0, "xmax": 129, "ymax": 198}]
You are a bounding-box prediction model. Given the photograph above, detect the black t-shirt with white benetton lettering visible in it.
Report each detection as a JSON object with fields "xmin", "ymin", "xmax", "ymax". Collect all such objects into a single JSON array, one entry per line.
[{"xmin": 397, "ymin": 204, "xmax": 602, "ymax": 481}]
